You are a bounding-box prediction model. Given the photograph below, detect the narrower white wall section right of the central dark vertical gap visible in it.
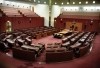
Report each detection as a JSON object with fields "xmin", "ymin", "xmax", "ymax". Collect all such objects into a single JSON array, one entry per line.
[{"xmin": 51, "ymin": 5, "xmax": 60, "ymax": 26}]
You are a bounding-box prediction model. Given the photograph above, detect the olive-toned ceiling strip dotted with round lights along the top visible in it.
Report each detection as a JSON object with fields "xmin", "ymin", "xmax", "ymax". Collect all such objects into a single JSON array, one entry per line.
[{"xmin": 5, "ymin": 0, "xmax": 100, "ymax": 5}]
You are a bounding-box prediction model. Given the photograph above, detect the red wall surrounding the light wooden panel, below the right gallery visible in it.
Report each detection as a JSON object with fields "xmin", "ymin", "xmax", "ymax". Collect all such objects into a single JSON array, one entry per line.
[{"xmin": 55, "ymin": 18, "xmax": 100, "ymax": 31}]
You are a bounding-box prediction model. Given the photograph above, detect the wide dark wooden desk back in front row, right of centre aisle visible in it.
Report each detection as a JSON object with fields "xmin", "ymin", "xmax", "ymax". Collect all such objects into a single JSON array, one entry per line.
[{"xmin": 46, "ymin": 51, "xmax": 73, "ymax": 62}]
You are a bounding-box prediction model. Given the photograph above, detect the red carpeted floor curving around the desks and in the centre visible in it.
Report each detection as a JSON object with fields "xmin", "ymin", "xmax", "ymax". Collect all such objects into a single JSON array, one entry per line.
[{"xmin": 0, "ymin": 35, "xmax": 100, "ymax": 68}]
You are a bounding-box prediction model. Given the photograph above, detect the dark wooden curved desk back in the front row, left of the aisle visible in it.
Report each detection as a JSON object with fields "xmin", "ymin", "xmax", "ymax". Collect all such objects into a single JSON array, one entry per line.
[{"xmin": 12, "ymin": 47, "xmax": 35, "ymax": 61}]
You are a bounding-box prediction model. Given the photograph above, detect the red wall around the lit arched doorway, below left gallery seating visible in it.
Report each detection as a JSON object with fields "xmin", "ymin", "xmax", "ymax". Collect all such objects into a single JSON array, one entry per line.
[{"xmin": 0, "ymin": 17, "xmax": 44, "ymax": 32}]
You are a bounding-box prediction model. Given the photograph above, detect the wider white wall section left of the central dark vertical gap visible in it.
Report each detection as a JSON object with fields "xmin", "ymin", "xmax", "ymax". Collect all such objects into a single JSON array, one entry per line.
[{"xmin": 33, "ymin": 4, "xmax": 49, "ymax": 26}]
